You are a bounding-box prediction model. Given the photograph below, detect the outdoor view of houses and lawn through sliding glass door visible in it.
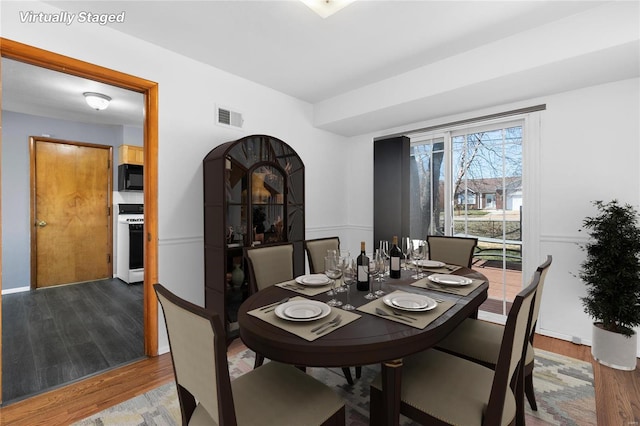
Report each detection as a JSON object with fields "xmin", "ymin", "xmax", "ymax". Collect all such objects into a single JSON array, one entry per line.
[{"xmin": 410, "ymin": 126, "xmax": 523, "ymax": 312}]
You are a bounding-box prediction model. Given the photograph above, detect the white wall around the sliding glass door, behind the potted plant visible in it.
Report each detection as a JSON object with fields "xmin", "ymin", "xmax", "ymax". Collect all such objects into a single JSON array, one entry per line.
[{"xmin": 348, "ymin": 78, "xmax": 640, "ymax": 356}]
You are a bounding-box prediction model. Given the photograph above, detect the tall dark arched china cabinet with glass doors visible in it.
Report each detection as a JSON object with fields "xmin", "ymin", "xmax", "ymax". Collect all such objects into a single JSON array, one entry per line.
[{"xmin": 203, "ymin": 135, "xmax": 305, "ymax": 337}]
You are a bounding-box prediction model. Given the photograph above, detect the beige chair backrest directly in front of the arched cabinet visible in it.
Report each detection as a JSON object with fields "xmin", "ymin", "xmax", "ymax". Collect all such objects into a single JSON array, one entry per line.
[{"xmin": 244, "ymin": 243, "xmax": 294, "ymax": 293}]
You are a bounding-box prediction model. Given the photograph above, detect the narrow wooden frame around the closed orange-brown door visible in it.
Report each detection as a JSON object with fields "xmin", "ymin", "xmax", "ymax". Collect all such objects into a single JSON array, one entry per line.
[{"xmin": 29, "ymin": 136, "xmax": 114, "ymax": 288}]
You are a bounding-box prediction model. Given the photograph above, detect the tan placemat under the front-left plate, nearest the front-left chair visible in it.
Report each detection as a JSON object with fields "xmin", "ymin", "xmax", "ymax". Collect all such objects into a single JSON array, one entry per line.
[{"xmin": 247, "ymin": 296, "xmax": 361, "ymax": 342}]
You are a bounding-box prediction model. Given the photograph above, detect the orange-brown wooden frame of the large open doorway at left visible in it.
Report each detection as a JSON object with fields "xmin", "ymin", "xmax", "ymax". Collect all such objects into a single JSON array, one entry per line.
[{"xmin": 0, "ymin": 37, "xmax": 158, "ymax": 401}]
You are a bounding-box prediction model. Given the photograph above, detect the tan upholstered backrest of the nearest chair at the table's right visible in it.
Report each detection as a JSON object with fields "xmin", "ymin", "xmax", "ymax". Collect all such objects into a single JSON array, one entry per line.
[{"xmin": 483, "ymin": 271, "xmax": 540, "ymax": 425}]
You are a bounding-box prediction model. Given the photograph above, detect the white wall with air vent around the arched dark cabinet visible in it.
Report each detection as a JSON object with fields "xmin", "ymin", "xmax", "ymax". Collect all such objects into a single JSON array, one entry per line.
[{"xmin": 0, "ymin": 2, "xmax": 347, "ymax": 352}]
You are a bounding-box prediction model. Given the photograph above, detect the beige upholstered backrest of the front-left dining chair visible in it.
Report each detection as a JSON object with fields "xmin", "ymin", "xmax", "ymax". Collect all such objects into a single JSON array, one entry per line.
[{"xmin": 153, "ymin": 284, "xmax": 236, "ymax": 425}]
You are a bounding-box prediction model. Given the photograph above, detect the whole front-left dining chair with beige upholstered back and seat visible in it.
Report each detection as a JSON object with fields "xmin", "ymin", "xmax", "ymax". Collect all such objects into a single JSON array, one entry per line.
[{"xmin": 153, "ymin": 284, "xmax": 345, "ymax": 426}]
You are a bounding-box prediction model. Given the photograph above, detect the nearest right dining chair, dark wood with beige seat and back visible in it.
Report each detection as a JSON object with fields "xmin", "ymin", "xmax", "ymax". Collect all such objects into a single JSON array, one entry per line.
[{"xmin": 369, "ymin": 271, "xmax": 540, "ymax": 426}]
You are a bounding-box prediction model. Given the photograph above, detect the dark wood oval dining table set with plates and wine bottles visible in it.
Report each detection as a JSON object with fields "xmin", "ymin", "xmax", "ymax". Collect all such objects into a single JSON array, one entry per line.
[{"xmin": 238, "ymin": 268, "xmax": 489, "ymax": 425}]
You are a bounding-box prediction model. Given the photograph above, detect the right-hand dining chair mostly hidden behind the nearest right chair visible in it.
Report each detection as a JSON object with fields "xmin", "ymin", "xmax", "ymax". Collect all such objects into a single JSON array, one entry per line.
[{"xmin": 436, "ymin": 255, "xmax": 553, "ymax": 411}]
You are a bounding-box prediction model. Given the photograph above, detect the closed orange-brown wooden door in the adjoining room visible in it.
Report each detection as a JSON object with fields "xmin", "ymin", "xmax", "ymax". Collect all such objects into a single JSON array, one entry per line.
[{"xmin": 31, "ymin": 138, "xmax": 112, "ymax": 288}]
